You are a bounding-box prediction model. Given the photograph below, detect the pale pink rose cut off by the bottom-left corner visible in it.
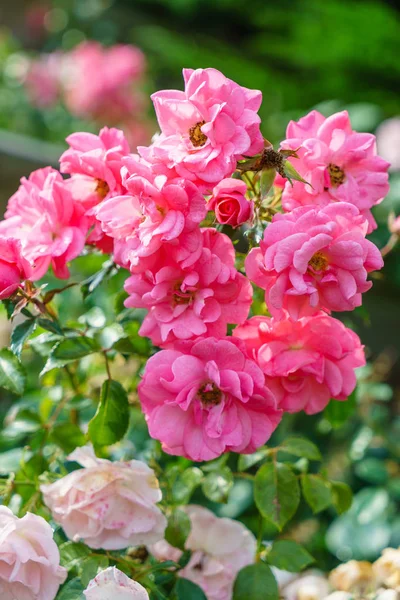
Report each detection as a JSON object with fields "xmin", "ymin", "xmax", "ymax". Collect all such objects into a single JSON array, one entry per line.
[{"xmin": 0, "ymin": 506, "xmax": 67, "ymax": 600}]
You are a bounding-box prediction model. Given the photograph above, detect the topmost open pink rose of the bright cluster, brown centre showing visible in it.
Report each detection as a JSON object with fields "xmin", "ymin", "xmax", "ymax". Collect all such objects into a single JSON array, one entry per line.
[{"xmin": 139, "ymin": 69, "xmax": 264, "ymax": 189}]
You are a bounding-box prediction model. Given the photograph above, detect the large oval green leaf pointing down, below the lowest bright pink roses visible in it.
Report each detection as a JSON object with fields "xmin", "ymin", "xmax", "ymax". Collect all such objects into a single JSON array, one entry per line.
[{"xmin": 254, "ymin": 463, "xmax": 300, "ymax": 530}]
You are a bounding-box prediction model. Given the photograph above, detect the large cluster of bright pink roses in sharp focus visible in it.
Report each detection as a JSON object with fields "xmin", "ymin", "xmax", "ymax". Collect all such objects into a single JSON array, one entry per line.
[{"xmin": 0, "ymin": 67, "xmax": 388, "ymax": 461}]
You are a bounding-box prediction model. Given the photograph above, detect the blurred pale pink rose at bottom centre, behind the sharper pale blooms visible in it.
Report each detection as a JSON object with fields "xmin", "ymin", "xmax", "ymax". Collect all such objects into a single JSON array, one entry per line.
[{"xmin": 150, "ymin": 505, "xmax": 257, "ymax": 600}]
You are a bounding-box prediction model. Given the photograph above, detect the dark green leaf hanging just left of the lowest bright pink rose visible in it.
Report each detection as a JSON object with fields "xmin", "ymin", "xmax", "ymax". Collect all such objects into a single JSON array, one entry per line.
[{"xmin": 89, "ymin": 379, "xmax": 129, "ymax": 446}]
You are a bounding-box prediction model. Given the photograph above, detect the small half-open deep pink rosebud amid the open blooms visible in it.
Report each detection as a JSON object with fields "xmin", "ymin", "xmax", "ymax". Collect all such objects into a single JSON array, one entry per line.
[{"xmin": 208, "ymin": 178, "xmax": 253, "ymax": 227}]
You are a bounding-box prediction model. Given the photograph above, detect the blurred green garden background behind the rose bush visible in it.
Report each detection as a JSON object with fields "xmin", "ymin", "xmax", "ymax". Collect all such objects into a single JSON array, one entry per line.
[{"xmin": 0, "ymin": 0, "xmax": 400, "ymax": 566}]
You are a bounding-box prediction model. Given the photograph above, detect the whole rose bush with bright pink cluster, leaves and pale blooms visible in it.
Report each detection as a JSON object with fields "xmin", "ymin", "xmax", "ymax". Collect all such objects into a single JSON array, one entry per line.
[{"xmin": 0, "ymin": 63, "xmax": 398, "ymax": 600}]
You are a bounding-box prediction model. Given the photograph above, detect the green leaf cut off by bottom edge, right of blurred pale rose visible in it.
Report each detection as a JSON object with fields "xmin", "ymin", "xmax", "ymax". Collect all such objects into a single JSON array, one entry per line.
[{"xmin": 232, "ymin": 563, "xmax": 279, "ymax": 600}]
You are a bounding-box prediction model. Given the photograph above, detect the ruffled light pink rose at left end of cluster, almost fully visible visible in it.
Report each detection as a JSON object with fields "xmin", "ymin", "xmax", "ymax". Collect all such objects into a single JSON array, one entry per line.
[{"xmin": 0, "ymin": 167, "xmax": 89, "ymax": 279}]
